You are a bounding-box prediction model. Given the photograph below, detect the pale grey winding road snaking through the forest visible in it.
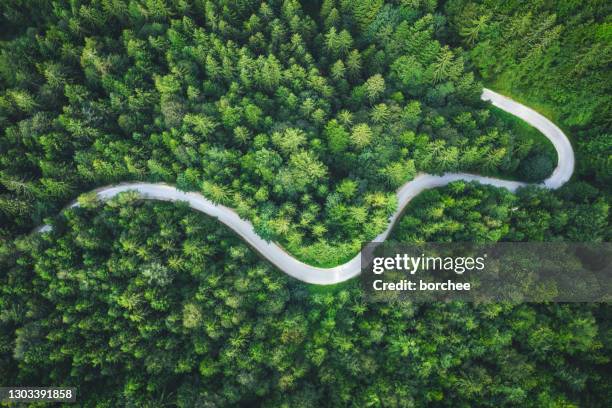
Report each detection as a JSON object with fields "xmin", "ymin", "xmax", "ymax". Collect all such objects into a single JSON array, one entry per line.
[{"xmin": 37, "ymin": 89, "xmax": 574, "ymax": 285}]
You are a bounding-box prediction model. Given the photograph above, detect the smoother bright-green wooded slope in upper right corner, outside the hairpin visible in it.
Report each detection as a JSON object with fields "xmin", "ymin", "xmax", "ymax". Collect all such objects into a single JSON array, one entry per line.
[{"xmin": 440, "ymin": 0, "xmax": 612, "ymax": 188}]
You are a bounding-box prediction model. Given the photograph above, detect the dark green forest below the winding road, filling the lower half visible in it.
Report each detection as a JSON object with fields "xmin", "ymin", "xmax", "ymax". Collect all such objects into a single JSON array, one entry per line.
[{"xmin": 0, "ymin": 196, "xmax": 612, "ymax": 407}]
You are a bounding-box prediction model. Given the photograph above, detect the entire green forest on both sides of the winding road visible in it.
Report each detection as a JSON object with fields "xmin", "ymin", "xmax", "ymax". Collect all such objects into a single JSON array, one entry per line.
[{"xmin": 0, "ymin": 0, "xmax": 612, "ymax": 407}]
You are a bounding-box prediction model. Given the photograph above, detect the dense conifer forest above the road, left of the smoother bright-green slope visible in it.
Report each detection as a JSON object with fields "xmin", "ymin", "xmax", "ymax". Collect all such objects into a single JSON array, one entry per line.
[{"xmin": 0, "ymin": 1, "xmax": 556, "ymax": 263}]
